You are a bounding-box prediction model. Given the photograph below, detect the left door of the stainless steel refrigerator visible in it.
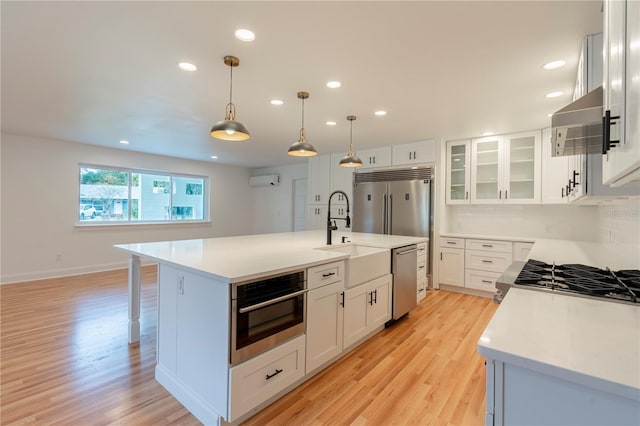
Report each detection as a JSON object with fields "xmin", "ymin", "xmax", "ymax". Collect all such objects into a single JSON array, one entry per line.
[{"xmin": 353, "ymin": 182, "xmax": 388, "ymax": 234}]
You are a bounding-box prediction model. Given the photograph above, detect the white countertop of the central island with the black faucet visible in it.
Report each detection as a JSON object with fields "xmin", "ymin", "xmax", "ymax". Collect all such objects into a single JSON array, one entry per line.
[{"xmin": 115, "ymin": 230, "xmax": 427, "ymax": 282}]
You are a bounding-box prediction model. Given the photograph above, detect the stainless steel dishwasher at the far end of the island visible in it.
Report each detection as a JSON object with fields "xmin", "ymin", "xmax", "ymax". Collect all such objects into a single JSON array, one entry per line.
[{"xmin": 391, "ymin": 244, "xmax": 418, "ymax": 320}]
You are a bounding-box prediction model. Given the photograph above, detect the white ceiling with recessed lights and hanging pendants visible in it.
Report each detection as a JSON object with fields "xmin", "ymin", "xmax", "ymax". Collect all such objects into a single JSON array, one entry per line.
[{"xmin": 1, "ymin": 1, "xmax": 602, "ymax": 167}]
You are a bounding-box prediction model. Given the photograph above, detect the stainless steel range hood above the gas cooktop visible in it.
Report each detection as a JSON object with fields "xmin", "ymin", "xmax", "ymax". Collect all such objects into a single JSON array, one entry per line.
[{"xmin": 551, "ymin": 86, "xmax": 603, "ymax": 157}]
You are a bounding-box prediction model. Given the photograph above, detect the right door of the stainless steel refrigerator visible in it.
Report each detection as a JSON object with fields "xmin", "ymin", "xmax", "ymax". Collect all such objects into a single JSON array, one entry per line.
[{"xmin": 387, "ymin": 179, "xmax": 431, "ymax": 238}]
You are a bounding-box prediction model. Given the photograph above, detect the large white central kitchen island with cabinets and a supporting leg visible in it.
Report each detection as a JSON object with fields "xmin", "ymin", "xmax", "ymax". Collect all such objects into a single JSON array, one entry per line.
[{"xmin": 116, "ymin": 231, "xmax": 426, "ymax": 424}]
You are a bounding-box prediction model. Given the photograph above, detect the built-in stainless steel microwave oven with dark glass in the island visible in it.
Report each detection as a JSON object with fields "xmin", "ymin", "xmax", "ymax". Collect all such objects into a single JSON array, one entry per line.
[{"xmin": 230, "ymin": 270, "xmax": 308, "ymax": 365}]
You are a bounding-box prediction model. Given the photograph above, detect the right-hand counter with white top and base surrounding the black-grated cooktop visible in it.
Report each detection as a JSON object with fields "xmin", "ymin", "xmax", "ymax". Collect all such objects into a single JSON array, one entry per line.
[{"xmin": 478, "ymin": 240, "xmax": 640, "ymax": 425}]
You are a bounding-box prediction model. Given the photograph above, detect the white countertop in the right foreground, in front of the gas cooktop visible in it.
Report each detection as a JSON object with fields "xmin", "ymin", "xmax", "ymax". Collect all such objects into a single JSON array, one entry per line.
[{"xmin": 478, "ymin": 288, "xmax": 640, "ymax": 401}]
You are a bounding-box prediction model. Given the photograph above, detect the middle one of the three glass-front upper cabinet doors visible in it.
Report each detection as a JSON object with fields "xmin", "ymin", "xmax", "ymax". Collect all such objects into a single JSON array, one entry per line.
[{"xmin": 471, "ymin": 136, "xmax": 504, "ymax": 203}]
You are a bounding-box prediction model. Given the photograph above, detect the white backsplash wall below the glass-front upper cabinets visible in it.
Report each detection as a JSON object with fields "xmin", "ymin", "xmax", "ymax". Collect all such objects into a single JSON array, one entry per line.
[{"xmin": 442, "ymin": 205, "xmax": 598, "ymax": 241}]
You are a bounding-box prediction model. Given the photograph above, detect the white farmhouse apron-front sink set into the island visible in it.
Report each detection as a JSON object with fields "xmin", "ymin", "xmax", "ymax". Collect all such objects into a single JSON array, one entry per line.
[{"xmin": 319, "ymin": 244, "xmax": 391, "ymax": 288}]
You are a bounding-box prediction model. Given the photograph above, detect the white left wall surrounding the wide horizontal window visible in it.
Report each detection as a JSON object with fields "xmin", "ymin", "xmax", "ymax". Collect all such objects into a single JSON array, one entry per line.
[{"xmin": 0, "ymin": 133, "xmax": 254, "ymax": 283}]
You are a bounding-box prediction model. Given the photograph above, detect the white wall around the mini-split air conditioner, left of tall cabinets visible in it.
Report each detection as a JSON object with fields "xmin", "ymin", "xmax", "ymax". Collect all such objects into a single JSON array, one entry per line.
[{"xmin": 251, "ymin": 164, "xmax": 308, "ymax": 234}]
